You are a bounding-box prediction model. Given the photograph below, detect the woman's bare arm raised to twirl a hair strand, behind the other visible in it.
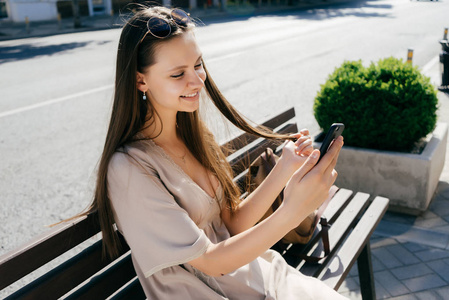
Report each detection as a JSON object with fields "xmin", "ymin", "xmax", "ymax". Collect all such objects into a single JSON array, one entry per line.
[{"xmin": 221, "ymin": 129, "xmax": 313, "ymax": 235}]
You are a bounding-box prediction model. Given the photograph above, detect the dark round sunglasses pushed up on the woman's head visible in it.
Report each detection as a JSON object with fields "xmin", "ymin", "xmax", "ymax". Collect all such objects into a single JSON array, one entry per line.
[{"xmin": 141, "ymin": 8, "xmax": 190, "ymax": 41}]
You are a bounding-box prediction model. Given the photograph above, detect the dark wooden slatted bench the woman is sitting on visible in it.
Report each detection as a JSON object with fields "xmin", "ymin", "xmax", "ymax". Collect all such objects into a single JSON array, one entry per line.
[{"xmin": 0, "ymin": 108, "xmax": 388, "ymax": 299}]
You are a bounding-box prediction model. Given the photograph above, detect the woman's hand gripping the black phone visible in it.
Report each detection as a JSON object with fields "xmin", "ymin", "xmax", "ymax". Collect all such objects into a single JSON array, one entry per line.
[{"xmin": 280, "ymin": 137, "xmax": 343, "ymax": 227}]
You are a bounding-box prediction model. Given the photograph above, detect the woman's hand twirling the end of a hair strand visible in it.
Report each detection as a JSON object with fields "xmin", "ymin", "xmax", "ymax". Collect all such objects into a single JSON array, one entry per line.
[{"xmin": 279, "ymin": 129, "xmax": 313, "ymax": 178}]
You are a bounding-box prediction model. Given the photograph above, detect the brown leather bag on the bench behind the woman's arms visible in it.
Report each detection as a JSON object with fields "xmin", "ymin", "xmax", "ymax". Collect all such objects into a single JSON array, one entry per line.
[{"xmin": 247, "ymin": 148, "xmax": 338, "ymax": 261}]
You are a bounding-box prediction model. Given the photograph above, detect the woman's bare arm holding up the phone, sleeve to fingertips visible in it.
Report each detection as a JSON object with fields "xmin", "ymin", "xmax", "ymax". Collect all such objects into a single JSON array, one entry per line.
[{"xmin": 189, "ymin": 137, "xmax": 343, "ymax": 276}]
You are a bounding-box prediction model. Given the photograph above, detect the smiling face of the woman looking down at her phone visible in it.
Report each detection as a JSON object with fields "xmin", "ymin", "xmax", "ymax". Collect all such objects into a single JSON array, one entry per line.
[{"xmin": 137, "ymin": 31, "xmax": 206, "ymax": 114}]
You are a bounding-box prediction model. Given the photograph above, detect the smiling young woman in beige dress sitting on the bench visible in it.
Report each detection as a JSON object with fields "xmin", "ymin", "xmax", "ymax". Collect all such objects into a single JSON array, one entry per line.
[{"xmin": 89, "ymin": 7, "xmax": 343, "ymax": 300}]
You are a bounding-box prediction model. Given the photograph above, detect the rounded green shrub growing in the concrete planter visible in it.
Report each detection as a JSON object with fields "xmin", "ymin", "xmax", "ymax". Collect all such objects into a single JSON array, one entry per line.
[{"xmin": 313, "ymin": 57, "xmax": 438, "ymax": 151}]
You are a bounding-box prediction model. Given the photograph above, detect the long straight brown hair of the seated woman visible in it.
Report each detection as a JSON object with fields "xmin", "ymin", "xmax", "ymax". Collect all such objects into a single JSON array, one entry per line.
[{"xmin": 79, "ymin": 7, "xmax": 291, "ymax": 257}]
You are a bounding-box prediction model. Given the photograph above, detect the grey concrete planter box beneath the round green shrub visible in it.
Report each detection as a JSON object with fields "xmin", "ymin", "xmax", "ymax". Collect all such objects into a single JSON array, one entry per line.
[{"xmin": 315, "ymin": 123, "xmax": 448, "ymax": 215}]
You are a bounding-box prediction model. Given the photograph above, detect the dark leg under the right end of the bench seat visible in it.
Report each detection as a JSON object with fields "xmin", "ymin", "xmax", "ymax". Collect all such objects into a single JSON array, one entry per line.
[{"xmin": 357, "ymin": 241, "xmax": 376, "ymax": 300}]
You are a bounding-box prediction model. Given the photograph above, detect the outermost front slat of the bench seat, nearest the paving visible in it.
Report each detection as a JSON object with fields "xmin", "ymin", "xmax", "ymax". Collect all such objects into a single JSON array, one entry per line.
[{"xmin": 317, "ymin": 197, "xmax": 389, "ymax": 289}]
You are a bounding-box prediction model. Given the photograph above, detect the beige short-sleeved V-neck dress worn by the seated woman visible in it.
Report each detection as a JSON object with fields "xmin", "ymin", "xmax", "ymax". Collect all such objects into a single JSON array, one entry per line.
[{"xmin": 108, "ymin": 141, "xmax": 342, "ymax": 300}]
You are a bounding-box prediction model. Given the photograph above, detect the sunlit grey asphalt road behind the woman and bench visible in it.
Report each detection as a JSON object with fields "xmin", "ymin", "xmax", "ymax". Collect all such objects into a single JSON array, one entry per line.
[{"xmin": 0, "ymin": 0, "xmax": 449, "ymax": 254}]
